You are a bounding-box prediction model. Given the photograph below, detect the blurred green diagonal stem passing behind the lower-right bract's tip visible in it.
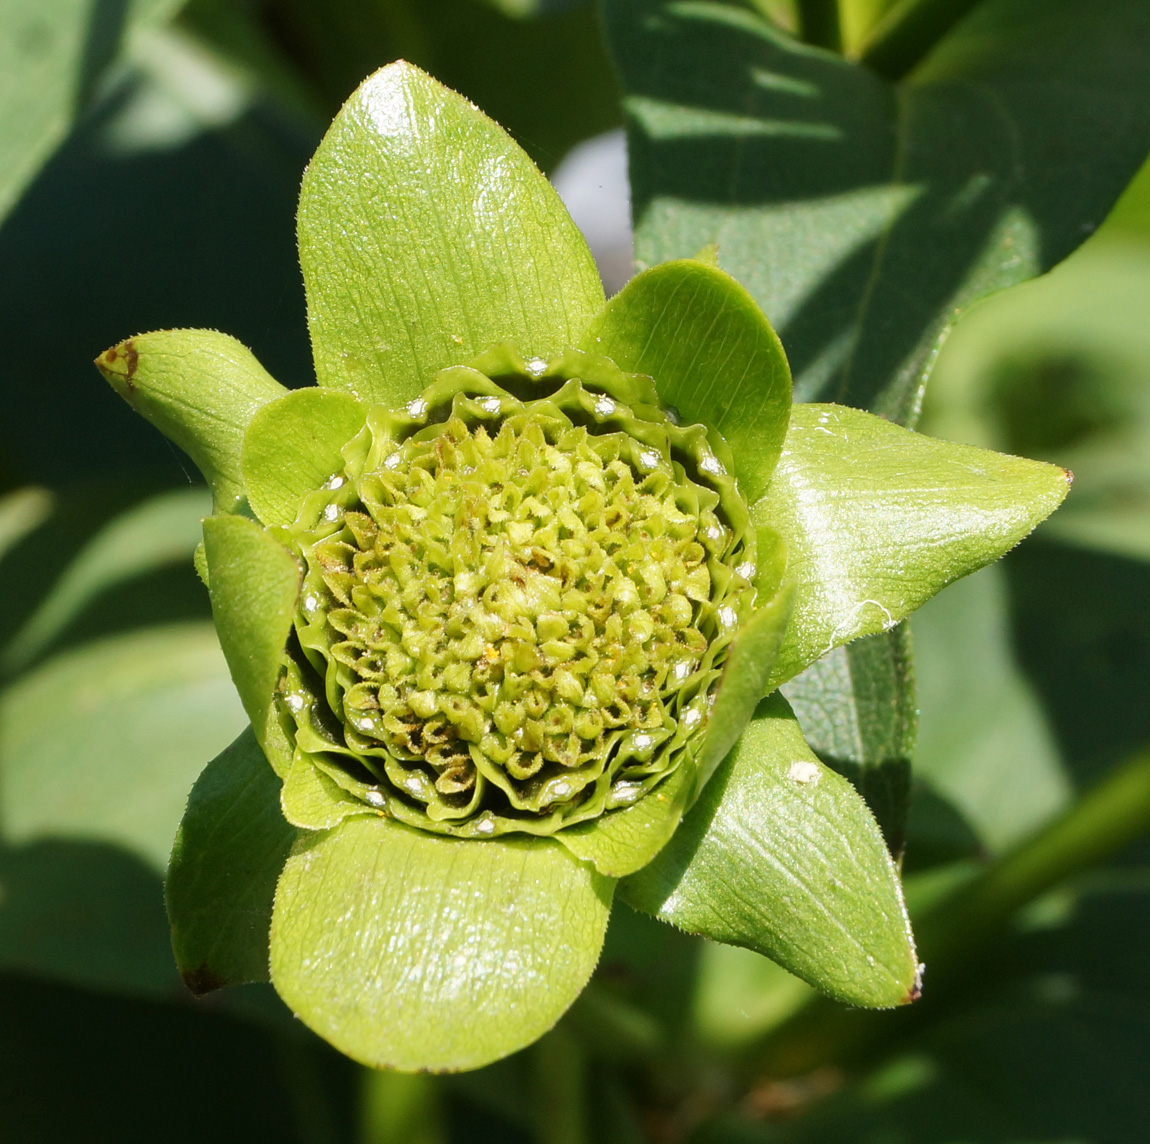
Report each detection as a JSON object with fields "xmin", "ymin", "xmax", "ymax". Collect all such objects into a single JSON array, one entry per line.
[{"xmin": 749, "ymin": 750, "xmax": 1150, "ymax": 1076}]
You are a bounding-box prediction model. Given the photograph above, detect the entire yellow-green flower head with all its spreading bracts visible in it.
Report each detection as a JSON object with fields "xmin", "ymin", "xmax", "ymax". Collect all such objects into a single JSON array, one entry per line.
[{"xmin": 98, "ymin": 56, "xmax": 1067, "ymax": 1069}]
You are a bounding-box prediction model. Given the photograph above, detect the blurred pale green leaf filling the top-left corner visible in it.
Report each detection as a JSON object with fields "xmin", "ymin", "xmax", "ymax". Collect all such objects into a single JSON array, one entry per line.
[{"xmin": 0, "ymin": 0, "xmax": 179, "ymax": 225}]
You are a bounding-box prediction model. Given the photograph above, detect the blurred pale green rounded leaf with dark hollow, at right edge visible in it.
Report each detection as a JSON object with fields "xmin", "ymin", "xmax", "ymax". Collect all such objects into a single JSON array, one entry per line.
[{"xmin": 926, "ymin": 236, "xmax": 1150, "ymax": 560}]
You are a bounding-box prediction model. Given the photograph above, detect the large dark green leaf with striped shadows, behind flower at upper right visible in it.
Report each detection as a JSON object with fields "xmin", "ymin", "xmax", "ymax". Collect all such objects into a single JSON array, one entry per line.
[{"xmin": 605, "ymin": 0, "xmax": 1150, "ymax": 422}]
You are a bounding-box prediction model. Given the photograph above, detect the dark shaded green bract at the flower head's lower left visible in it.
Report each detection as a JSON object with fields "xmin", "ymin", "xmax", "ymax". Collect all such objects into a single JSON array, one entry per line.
[{"xmin": 164, "ymin": 728, "xmax": 297, "ymax": 993}]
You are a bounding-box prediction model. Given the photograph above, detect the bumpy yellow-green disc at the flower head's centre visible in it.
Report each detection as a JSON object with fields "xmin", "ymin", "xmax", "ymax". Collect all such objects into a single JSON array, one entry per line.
[{"xmin": 303, "ymin": 413, "xmax": 725, "ymax": 813}]
